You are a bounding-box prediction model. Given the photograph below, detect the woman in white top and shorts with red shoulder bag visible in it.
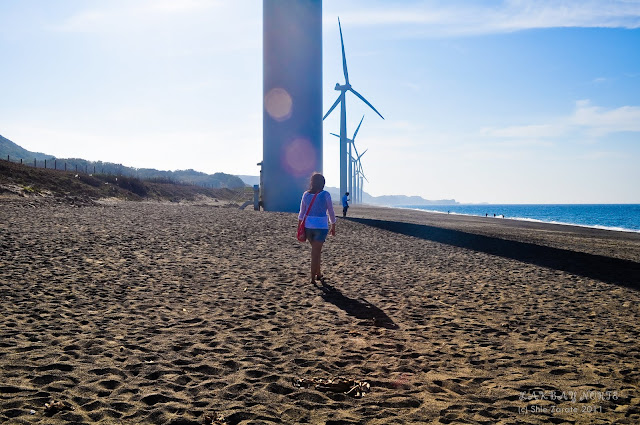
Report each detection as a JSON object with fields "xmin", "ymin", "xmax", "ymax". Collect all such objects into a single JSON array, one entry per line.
[{"xmin": 298, "ymin": 173, "xmax": 336, "ymax": 283}]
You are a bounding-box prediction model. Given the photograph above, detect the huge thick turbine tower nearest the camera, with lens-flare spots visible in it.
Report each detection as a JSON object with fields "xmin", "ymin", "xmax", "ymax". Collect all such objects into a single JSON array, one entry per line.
[{"xmin": 261, "ymin": 0, "xmax": 322, "ymax": 212}]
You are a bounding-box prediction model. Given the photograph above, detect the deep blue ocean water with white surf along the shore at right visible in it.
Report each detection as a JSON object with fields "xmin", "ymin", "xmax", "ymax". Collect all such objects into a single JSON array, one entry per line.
[{"xmin": 401, "ymin": 204, "xmax": 640, "ymax": 233}]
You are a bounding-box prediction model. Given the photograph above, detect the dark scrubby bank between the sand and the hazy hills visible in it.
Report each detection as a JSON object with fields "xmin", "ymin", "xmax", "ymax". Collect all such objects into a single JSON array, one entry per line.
[{"xmin": 0, "ymin": 160, "xmax": 253, "ymax": 205}]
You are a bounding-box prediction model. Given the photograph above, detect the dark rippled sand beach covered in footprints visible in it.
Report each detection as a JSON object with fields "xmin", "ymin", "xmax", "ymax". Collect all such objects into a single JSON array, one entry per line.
[{"xmin": 0, "ymin": 198, "xmax": 640, "ymax": 425}]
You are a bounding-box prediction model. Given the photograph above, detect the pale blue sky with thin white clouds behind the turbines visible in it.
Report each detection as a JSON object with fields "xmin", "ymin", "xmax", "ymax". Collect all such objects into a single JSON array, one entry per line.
[{"xmin": 0, "ymin": 0, "xmax": 640, "ymax": 203}]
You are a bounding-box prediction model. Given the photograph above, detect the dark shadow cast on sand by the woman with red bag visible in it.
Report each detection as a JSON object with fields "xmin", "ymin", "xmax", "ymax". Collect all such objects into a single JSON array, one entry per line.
[{"xmin": 320, "ymin": 281, "xmax": 399, "ymax": 329}]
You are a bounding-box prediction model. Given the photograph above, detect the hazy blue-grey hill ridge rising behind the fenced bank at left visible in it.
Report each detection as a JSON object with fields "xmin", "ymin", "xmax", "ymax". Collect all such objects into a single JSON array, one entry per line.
[{"xmin": 0, "ymin": 136, "xmax": 245, "ymax": 189}]
